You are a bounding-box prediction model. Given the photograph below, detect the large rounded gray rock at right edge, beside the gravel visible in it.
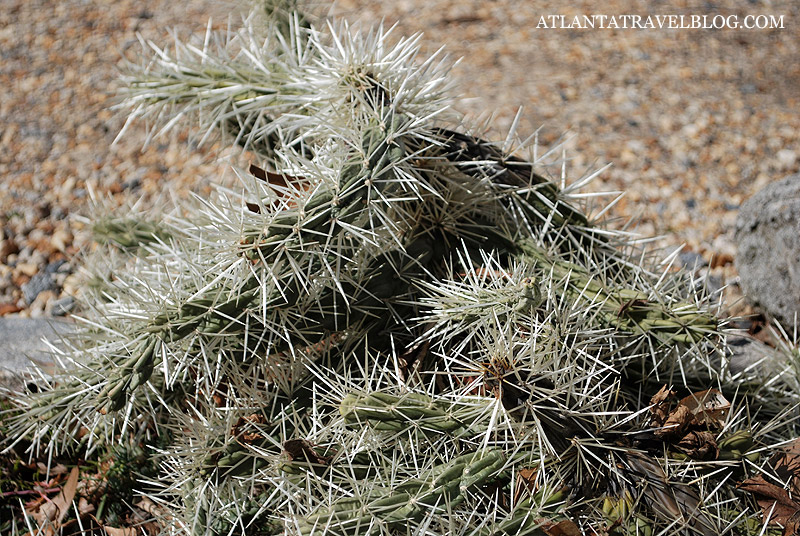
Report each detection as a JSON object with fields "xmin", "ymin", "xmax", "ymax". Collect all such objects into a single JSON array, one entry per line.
[{"xmin": 736, "ymin": 174, "xmax": 800, "ymax": 326}]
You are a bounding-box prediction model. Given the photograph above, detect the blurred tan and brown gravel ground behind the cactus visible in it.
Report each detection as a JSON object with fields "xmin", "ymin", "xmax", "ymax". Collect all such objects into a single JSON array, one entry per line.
[{"xmin": 0, "ymin": 0, "xmax": 800, "ymax": 316}]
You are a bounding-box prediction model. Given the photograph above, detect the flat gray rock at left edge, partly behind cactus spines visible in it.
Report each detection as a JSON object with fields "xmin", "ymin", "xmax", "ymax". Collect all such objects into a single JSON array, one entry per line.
[{"xmin": 0, "ymin": 317, "xmax": 75, "ymax": 386}]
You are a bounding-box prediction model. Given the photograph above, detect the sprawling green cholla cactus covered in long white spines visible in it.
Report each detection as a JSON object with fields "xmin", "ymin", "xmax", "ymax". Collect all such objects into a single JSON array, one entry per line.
[{"xmin": 3, "ymin": 3, "xmax": 798, "ymax": 536}]
